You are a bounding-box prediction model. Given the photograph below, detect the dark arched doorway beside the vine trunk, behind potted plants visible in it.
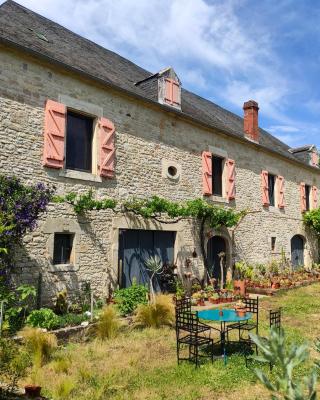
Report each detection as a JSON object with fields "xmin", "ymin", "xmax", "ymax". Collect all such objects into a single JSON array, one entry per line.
[{"xmin": 207, "ymin": 236, "xmax": 227, "ymax": 282}]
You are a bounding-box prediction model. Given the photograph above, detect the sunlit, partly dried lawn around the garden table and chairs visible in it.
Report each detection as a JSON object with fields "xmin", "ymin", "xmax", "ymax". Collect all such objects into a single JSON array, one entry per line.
[{"xmin": 23, "ymin": 284, "xmax": 320, "ymax": 400}]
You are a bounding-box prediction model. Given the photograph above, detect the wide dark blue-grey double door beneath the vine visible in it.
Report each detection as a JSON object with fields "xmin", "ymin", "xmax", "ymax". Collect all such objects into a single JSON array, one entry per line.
[{"xmin": 119, "ymin": 229, "xmax": 176, "ymax": 291}]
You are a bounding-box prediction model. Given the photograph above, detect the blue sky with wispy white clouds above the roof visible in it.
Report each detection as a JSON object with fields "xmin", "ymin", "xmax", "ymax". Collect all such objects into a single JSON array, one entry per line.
[{"xmin": 4, "ymin": 0, "xmax": 320, "ymax": 147}]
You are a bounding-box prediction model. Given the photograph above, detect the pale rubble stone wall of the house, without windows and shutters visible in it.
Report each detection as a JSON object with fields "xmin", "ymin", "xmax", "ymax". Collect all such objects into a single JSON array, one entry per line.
[{"xmin": 0, "ymin": 45, "xmax": 320, "ymax": 302}]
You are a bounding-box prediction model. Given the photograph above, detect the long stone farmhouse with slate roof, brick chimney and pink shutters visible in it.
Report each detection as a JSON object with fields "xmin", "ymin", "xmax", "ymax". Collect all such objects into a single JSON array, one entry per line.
[{"xmin": 0, "ymin": 0, "xmax": 320, "ymax": 301}]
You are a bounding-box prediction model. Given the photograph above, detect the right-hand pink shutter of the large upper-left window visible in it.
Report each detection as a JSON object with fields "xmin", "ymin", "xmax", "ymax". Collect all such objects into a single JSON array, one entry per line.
[{"xmin": 98, "ymin": 118, "xmax": 115, "ymax": 178}]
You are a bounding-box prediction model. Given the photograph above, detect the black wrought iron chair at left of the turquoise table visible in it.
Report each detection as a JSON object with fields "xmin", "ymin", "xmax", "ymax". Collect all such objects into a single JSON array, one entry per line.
[{"xmin": 176, "ymin": 298, "xmax": 213, "ymax": 367}]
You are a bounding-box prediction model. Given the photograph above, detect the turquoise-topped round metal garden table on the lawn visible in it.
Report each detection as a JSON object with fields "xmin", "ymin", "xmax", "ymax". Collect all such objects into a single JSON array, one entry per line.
[{"xmin": 197, "ymin": 309, "xmax": 252, "ymax": 364}]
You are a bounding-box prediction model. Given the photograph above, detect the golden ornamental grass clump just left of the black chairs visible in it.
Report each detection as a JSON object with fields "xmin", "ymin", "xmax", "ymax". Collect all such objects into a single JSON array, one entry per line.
[{"xmin": 136, "ymin": 294, "xmax": 174, "ymax": 328}]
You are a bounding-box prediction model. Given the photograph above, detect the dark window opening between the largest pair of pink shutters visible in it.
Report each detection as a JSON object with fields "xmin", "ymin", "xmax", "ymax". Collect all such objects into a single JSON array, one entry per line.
[{"xmin": 66, "ymin": 112, "xmax": 93, "ymax": 172}]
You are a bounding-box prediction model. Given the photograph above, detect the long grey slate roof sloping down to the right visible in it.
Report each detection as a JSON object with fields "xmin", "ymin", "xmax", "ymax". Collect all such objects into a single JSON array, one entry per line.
[{"xmin": 0, "ymin": 0, "xmax": 316, "ymax": 166}]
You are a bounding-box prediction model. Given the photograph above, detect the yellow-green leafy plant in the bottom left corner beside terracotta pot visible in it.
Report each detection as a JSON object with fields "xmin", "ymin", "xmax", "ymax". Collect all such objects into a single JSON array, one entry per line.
[{"xmin": 0, "ymin": 339, "xmax": 30, "ymax": 392}]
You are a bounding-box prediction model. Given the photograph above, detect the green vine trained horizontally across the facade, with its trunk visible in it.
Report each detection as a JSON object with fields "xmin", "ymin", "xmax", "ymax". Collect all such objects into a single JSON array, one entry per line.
[{"xmin": 54, "ymin": 190, "xmax": 246, "ymax": 282}]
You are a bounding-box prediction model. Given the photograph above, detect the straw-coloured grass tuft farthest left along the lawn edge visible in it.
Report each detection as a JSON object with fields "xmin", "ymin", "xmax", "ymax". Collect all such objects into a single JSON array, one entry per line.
[{"xmin": 20, "ymin": 327, "xmax": 57, "ymax": 367}]
